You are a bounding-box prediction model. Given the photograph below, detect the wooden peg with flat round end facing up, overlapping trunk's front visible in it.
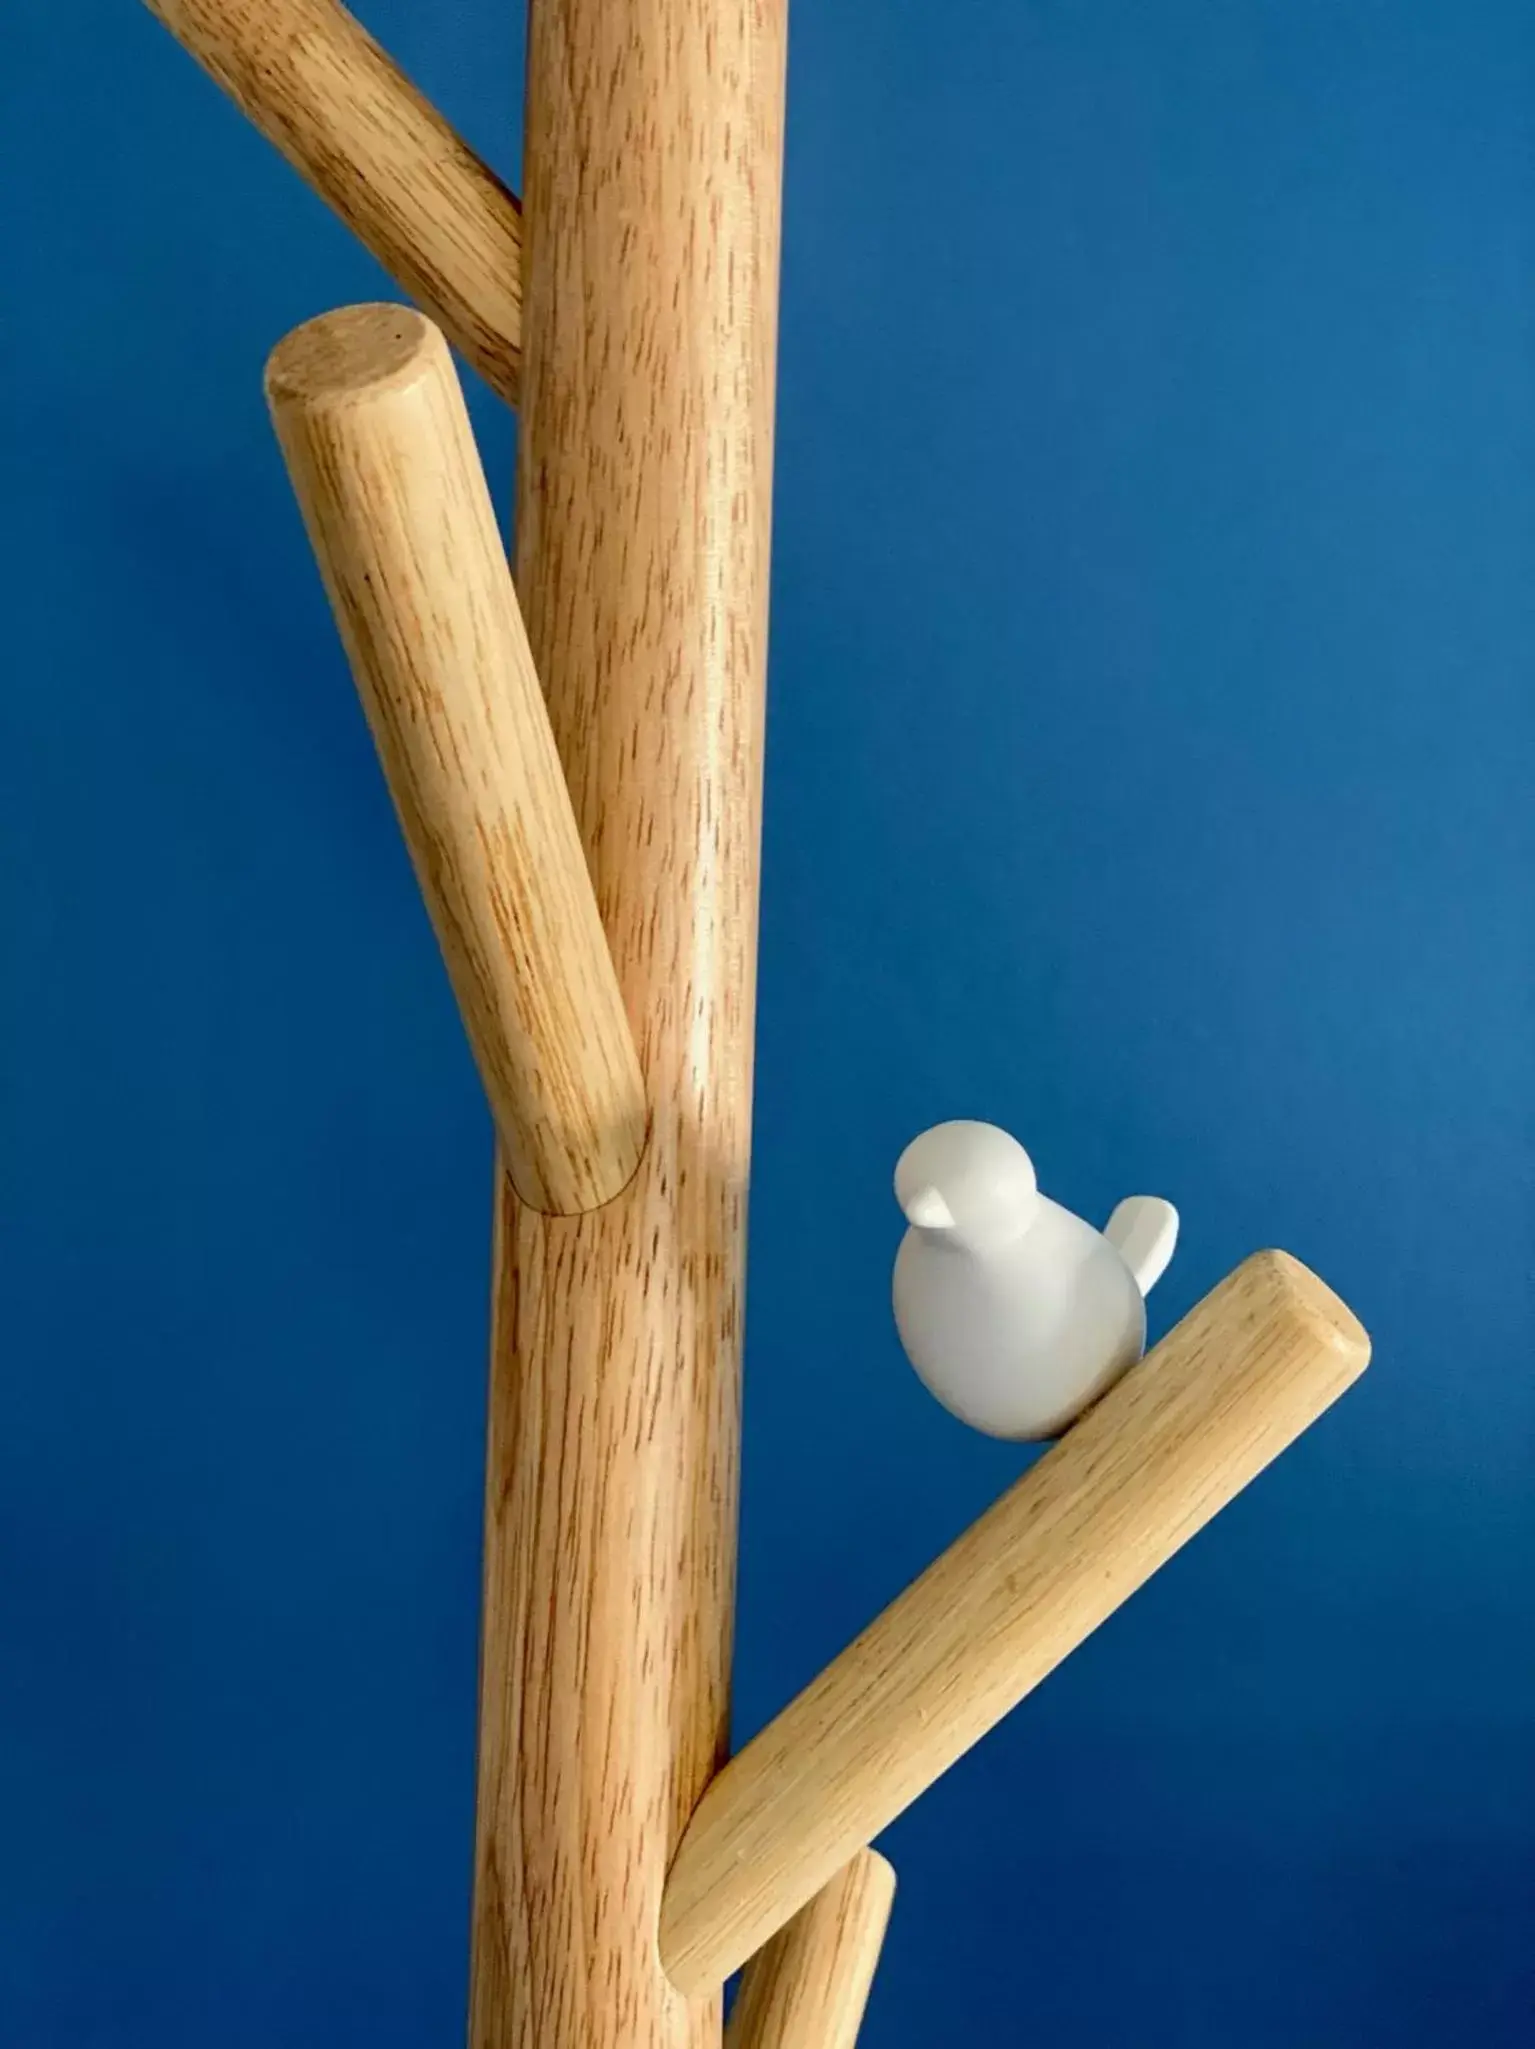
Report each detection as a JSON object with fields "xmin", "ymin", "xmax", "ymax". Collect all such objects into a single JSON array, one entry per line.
[{"xmin": 266, "ymin": 305, "xmax": 646, "ymax": 1213}]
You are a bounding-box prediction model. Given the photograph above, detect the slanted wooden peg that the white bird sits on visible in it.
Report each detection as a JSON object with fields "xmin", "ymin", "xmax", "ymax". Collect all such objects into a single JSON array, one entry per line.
[{"xmin": 662, "ymin": 1252, "xmax": 1369, "ymax": 1994}]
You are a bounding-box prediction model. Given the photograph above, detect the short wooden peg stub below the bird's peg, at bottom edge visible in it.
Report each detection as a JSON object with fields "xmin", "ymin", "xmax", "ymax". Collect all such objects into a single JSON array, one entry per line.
[{"xmin": 725, "ymin": 1850, "xmax": 896, "ymax": 2049}]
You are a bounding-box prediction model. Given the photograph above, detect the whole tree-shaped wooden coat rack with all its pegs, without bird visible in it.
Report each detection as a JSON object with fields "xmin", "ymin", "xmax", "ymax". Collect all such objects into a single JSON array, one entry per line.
[{"xmin": 134, "ymin": 0, "xmax": 1369, "ymax": 2049}]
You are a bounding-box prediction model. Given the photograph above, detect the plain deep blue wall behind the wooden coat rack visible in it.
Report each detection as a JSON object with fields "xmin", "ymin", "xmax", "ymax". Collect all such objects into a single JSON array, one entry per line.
[{"xmin": 0, "ymin": 0, "xmax": 1535, "ymax": 2049}]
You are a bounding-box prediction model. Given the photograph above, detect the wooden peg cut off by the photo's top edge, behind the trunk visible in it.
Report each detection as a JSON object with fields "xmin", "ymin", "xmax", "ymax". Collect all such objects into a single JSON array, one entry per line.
[{"xmin": 146, "ymin": 0, "xmax": 523, "ymax": 402}]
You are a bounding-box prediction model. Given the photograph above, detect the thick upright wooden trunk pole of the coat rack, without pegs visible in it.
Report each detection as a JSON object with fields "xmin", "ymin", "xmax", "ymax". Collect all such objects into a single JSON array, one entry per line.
[{"xmin": 469, "ymin": 0, "xmax": 785, "ymax": 2049}]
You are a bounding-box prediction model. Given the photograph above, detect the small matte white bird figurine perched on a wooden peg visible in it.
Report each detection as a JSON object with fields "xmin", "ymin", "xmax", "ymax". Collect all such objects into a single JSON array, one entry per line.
[{"xmin": 894, "ymin": 1121, "xmax": 1178, "ymax": 1438}]
